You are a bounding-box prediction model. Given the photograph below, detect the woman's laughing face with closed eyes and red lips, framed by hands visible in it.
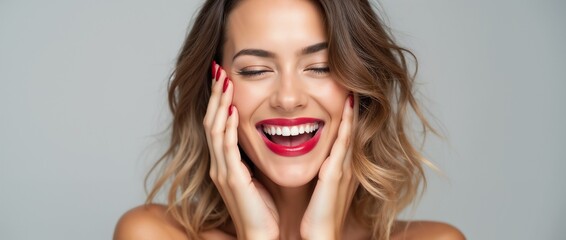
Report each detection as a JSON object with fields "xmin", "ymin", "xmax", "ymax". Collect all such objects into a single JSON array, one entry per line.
[{"xmin": 222, "ymin": 0, "xmax": 348, "ymax": 187}]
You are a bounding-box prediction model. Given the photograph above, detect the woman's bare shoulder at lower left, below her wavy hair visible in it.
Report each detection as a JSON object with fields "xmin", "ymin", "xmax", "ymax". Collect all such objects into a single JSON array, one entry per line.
[{"xmin": 114, "ymin": 204, "xmax": 236, "ymax": 240}]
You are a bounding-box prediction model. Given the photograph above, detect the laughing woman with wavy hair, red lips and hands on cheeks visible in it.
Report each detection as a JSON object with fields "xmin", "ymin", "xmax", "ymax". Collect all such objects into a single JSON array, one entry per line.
[{"xmin": 114, "ymin": 0, "xmax": 463, "ymax": 240}]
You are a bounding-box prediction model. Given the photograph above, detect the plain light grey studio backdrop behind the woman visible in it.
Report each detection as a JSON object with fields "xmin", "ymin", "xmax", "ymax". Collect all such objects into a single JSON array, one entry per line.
[{"xmin": 0, "ymin": 0, "xmax": 566, "ymax": 240}]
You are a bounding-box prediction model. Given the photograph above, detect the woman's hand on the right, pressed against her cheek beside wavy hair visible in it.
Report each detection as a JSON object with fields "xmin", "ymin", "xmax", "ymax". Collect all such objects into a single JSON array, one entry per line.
[{"xmin": 301, "ymin": 95, "xmax": 358, "ymax": 240}]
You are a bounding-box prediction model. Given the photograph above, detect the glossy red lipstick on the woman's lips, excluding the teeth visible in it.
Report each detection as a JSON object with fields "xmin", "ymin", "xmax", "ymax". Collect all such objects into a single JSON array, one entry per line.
[{"xmin": 256, "ymin": 118, "xmax": 324, "ymax": 157}]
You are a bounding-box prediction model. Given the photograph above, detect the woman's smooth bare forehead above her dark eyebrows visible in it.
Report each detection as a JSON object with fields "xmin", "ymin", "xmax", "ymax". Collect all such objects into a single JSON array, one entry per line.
[{"xmin": 226, "ymin": 0, "xmax": 326, "ymax": 54}]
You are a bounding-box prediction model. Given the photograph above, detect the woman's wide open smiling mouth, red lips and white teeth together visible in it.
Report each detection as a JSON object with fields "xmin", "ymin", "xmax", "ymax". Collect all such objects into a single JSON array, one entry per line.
[{"xmin": 256, "ymin": 118, "xmax": 324, "ymax": 157}]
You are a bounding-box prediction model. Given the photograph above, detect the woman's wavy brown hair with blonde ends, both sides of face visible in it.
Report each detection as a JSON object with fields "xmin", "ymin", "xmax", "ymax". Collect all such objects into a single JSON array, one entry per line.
[{"xmin": 146, "ymin": 0, "xmax": 431, "ymax": 239}]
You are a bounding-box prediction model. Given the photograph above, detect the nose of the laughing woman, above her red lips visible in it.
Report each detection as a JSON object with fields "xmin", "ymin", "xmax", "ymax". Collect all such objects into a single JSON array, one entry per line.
[{"xmin": 270, "ymin": 74, "xmax": 307, "ymax": 112}]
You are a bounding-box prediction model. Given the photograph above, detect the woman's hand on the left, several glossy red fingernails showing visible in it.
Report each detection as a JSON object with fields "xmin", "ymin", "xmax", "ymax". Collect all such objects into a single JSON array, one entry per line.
[{"xmin": 203, "ymin": 62, "xmax": 279, "ymax": 239}]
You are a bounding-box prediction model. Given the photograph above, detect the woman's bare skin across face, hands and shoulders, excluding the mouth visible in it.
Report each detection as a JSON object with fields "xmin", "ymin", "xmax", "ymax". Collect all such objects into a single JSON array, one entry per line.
[{"xmin": 114, "ymin": 0, "xmax": 463, "ymax": 239}]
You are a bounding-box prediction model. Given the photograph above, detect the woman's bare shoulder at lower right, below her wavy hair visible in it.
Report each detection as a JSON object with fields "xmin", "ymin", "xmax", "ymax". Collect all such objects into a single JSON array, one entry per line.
[{"xmin": 391, "ymin": 221, "xmax": 466, "ymax": 240}]
